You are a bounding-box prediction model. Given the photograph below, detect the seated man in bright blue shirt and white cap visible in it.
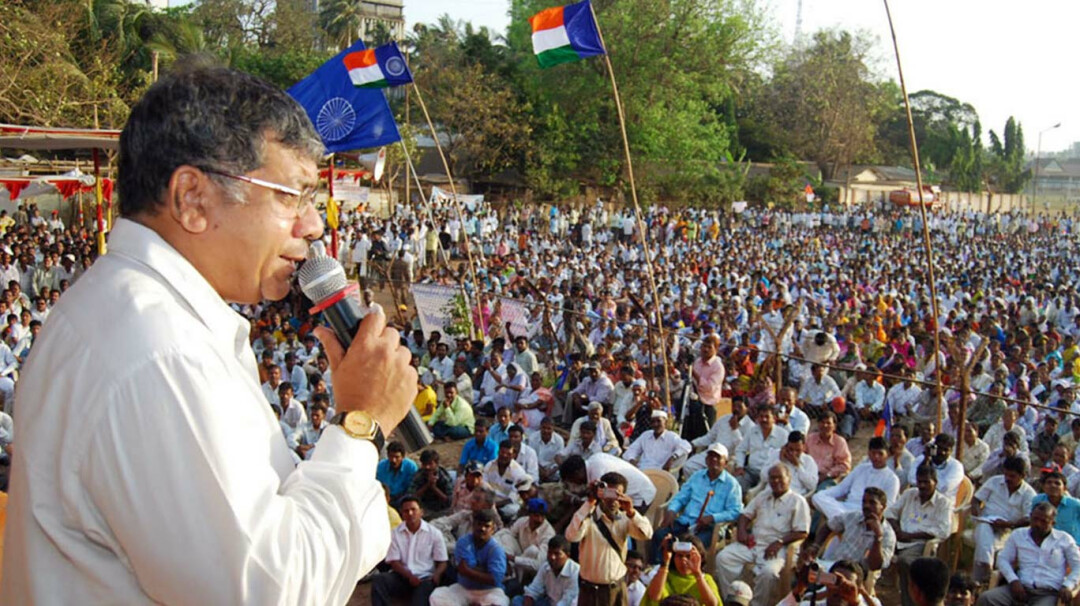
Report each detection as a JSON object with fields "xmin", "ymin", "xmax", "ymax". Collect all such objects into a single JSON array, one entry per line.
[{"xmin": 653, "ymin": 442, "xmax": 742, "ymax": 564}]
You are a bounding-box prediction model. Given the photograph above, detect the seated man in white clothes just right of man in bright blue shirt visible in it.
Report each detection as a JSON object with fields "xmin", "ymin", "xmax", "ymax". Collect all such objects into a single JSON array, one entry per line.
[{"xmin": 716, "ymin": 463, "xmax": 810, "ymax": 606}]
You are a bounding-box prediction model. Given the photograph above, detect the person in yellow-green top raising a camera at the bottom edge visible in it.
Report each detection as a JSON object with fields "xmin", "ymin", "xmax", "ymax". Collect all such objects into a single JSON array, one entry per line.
[{"xmin": 645, "ymin": 533, "xmax": 720, "ymax": 606}]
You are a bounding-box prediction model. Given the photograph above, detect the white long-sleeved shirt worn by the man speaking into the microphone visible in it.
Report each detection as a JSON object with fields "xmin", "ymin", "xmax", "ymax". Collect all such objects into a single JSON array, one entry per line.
[{"xmin": 0, "ymin": 219, "xmax": 390, "ymax": 604}]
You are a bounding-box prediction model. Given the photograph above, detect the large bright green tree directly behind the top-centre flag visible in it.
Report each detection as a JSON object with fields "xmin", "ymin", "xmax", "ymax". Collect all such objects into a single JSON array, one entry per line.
[{"xmin": 507, "ymin": 0, "xmax": 771, "ymax": 198}]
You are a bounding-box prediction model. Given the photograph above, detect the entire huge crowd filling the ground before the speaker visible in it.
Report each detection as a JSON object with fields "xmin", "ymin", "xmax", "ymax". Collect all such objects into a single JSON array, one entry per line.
[{"xmin": 0, "ymin": 194, "xmax": 1080, "ymax": 606}]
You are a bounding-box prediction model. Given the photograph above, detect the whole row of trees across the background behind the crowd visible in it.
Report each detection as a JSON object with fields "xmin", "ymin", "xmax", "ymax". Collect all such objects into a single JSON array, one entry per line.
[{"xmin": 0, "ymin": 0, "xmax": 1010, "ymax": 204}]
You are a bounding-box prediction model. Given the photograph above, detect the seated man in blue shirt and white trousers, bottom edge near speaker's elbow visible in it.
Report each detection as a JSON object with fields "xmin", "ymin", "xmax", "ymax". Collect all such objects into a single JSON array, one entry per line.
[{"xmin": 431, "ymin": 509, "xmax": 510, "ymax": 606}]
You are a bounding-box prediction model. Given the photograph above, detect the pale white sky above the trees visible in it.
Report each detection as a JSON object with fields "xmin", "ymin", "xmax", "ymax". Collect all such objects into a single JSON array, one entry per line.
[{"xmin": 405, "ymin": 0, "xmax": 1080, "ymax": 152}]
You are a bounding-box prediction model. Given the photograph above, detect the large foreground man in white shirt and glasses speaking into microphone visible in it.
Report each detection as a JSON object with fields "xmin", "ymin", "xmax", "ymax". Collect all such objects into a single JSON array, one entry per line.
[{"xmin": 0, "ymin": 67, "xmax": 417, "ymax": 605}]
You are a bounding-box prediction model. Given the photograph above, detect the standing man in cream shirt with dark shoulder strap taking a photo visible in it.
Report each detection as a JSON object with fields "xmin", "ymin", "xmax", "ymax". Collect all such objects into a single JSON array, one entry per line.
[{"xmin": 566, "ymin": 472, "xmax": 652, "ymax": 606}]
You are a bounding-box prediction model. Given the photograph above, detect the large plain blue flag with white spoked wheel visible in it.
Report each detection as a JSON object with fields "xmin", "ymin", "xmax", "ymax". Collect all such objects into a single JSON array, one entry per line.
[{"xmin": 288, "ymin": 40, "xmax": 402, "ymax": 152}]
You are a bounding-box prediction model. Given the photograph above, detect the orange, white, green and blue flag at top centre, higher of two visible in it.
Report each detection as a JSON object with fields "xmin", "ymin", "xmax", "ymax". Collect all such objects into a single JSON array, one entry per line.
[{"xmin": 529, "ymin": 0, "xmax": 605, "ymax": 67}]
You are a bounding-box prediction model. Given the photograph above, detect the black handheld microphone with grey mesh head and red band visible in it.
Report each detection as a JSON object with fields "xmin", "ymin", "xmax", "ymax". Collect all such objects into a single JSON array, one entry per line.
[{"xmin": 297, "ymin": 254, "xmax": 433, "ymax": 452}]
